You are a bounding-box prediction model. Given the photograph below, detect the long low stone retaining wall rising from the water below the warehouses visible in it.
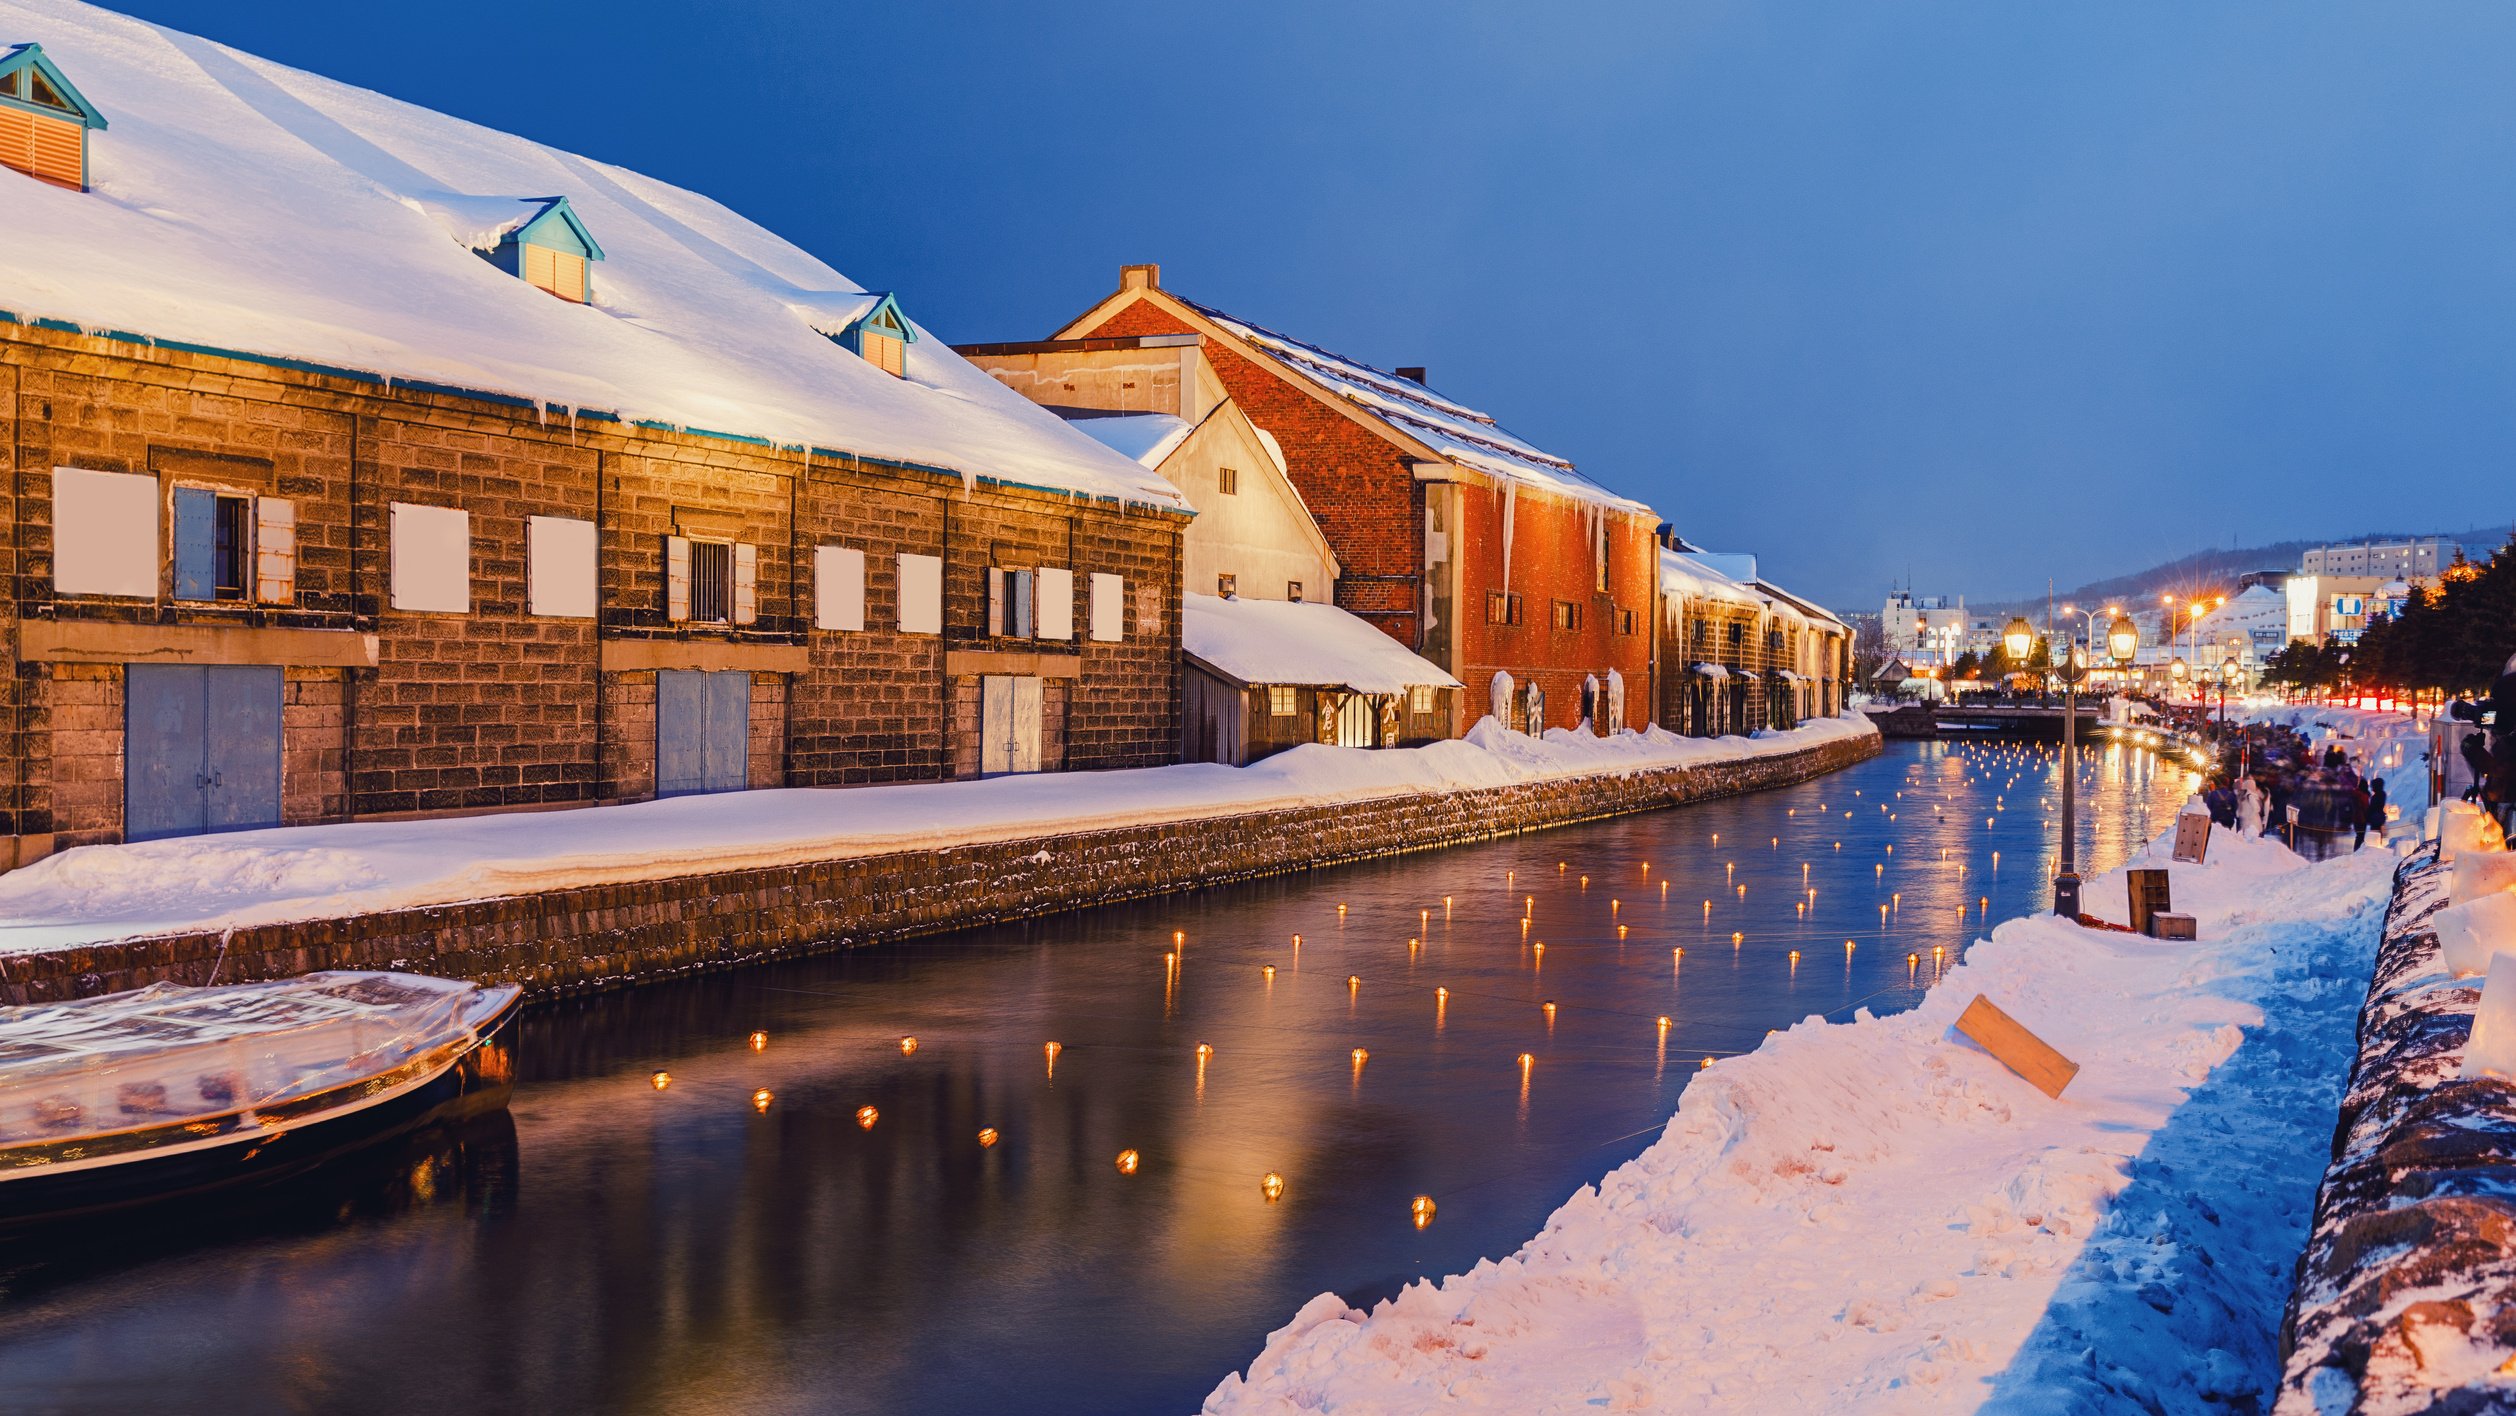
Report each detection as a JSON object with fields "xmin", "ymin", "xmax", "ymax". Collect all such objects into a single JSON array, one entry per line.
[{"xmin": 0, "ymin": 734, "xmax": 1879, "ymax": 1004}]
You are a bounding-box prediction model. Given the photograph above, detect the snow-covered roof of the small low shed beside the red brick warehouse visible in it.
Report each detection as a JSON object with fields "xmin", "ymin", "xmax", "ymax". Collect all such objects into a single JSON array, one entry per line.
[{"xmin": 1180, "ymin": 594, "xmax": 1459, "ymax": 694}]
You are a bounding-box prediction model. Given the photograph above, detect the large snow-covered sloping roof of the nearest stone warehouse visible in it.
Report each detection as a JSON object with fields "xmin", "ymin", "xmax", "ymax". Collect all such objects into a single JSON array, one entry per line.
[{"xmin": 0, "ymin": 0, "xmax": 1185, "ymax": 508}]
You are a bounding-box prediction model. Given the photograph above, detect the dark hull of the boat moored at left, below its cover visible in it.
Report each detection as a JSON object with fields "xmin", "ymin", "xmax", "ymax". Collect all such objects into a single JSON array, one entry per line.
[{"xmin": 0, "ymin": 1001, "xmax": 518, "ymax": 1232}]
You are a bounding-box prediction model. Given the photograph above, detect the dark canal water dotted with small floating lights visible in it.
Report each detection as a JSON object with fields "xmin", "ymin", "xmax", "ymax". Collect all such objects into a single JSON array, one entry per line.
[{"xmin": 0, "ymin": 744, "xmax": 2191, "ymax": 1413}]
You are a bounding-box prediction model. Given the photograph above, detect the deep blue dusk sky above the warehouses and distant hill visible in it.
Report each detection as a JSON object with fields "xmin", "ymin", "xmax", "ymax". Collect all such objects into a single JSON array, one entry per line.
[{"xmin": 98, "ymin": 0, "xmax": 2516, "ymax": 609}]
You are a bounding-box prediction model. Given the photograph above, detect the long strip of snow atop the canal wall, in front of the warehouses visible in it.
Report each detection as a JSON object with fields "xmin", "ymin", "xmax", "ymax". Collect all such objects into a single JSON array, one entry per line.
[{"xmin": 0, "ymin": 717, "xmax": 1877, "ymax": 956}]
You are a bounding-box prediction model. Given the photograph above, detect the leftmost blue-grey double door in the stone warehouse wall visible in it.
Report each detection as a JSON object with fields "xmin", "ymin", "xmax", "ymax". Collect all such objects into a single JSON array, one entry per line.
[{"xmin": 123, "ymin": 664, "xmax": 282, "ymax": 840}]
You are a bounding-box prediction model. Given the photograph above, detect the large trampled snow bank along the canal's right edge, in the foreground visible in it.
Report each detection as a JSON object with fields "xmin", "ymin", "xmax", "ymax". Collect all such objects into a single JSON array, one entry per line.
[{"xmin": 1205, "ymin": 814, "xmax": 2390, "ymax": 1416}]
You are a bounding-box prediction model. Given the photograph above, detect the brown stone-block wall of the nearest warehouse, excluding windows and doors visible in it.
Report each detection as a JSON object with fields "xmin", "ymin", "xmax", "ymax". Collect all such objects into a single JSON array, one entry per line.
[{"xmin": 0, "ymin": 324, "xmax": 1183, "ymax": 855}]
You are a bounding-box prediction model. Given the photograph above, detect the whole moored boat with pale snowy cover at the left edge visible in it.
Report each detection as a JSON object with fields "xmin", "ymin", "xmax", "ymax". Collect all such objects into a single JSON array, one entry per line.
[{"xmin": 0, "ymin": 971, "xmax": 518, "ymax": 1227}]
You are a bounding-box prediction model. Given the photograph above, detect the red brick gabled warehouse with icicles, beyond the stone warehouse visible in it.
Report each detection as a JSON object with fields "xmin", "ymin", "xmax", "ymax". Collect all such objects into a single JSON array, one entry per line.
[{"xmin": 1031, "ymin": 267, "xmax": 1658, "ymax": 732}]
